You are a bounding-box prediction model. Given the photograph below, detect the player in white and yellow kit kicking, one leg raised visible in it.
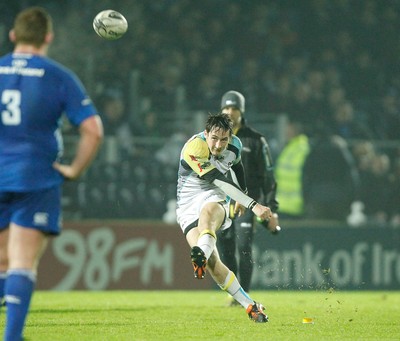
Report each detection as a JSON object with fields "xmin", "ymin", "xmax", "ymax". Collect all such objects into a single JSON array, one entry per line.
[{"xmin": 176, "ymin": 113, "xmax": 272, "ymax": 322}]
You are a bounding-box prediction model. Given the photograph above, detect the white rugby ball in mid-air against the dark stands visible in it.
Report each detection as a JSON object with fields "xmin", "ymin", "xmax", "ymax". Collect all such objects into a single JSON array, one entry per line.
[{"xmin": 93, "ymin": 9, "xmax": 128, "ymax": 40}]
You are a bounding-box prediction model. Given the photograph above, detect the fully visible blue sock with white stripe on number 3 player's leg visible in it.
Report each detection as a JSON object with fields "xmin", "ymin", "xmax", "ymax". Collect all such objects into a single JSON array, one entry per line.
[{"xmin": 4, "ymin": 269, "xmax": 36, "ymax": 341}]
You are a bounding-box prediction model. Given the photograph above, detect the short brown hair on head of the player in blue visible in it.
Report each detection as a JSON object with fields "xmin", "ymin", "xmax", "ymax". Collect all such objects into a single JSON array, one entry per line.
[{"xmin": 14, "ymin": 7, "xmax": 53, "ymax": 48}]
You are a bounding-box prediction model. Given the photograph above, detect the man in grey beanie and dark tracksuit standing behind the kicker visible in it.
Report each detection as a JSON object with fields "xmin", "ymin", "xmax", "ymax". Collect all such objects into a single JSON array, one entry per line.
[{"xmin": 218, "ymin": 91, "xmax": 279, "ymax": 305}]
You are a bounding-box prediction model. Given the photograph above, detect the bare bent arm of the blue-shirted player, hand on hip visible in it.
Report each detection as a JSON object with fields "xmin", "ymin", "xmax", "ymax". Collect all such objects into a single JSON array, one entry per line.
[{"xmin": 53, "ymin": 115, "xmax": 103, "ymax": 180}]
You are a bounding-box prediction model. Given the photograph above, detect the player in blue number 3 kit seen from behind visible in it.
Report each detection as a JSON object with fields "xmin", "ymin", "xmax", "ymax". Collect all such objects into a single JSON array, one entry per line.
[{"xmin": 0, "ymin": 7, "xmax": 103, "ymax": 341}]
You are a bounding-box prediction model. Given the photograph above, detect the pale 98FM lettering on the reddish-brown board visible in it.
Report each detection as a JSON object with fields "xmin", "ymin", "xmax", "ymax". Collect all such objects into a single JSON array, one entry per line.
[{"xmin": 52, "ymin": 227, "xmax": 173, "ymax": 290}]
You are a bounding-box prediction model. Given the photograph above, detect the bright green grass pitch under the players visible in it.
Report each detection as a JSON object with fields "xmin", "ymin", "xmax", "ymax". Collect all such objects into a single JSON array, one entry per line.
[{"xmin": 0, "ymin": 290, "xmax": 400, "ymax": 341}]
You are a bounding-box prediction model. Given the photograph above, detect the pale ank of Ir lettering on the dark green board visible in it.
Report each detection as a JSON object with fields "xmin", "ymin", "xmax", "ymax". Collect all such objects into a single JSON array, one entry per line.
[{"xmin": 252, "ymin": 242, "xmax": 400, "ymax": 288}]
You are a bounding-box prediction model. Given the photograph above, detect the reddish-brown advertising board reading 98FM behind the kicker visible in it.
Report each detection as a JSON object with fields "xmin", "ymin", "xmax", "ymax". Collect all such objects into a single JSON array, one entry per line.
[{"xmin": 38, "ymin": 223, "xmax": 211, "ymax": 290}]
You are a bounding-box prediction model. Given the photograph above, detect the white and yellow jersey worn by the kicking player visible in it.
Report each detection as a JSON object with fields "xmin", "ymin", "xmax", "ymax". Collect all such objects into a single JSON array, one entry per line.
[{"xmin": 177, "ymin": 132, "xmax": 242, "ymax": 208}]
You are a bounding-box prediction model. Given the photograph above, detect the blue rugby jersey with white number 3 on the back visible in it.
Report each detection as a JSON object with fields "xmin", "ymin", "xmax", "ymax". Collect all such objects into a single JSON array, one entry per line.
[{"xmin": 0, "ymin": 53, "xmax": 97, "ymax": 192}]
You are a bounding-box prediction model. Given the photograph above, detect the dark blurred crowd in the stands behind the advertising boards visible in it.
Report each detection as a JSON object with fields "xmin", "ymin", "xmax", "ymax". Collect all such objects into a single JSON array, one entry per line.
[{"xmin": 0, "ymin": 0, "xmax": 400, "ymax": 227}]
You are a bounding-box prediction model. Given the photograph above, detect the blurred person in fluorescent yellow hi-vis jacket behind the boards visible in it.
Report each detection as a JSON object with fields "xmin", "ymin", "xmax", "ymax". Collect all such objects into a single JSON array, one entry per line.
[{"xmin": 275, "ymin": 117, "xmax": 310, "ymax": 219}]
